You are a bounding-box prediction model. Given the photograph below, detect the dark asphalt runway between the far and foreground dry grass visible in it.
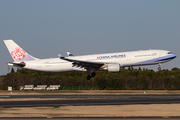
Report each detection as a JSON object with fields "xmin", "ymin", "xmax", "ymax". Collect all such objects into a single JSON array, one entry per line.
[{"xmin": 0, "ymin": 95, "xmax": 180, "ymax": 107}]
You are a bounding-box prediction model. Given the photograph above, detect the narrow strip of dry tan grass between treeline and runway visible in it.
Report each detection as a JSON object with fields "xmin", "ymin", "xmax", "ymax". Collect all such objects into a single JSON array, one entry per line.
[{"xmin": 0, "ymin": 90, "xmax": 180, "ymax": 95}]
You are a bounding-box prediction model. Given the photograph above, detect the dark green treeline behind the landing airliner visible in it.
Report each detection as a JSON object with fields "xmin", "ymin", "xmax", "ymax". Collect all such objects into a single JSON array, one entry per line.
[{"xmin": 0, "ymin": 67, "xmax": 180, "ymax": 90}]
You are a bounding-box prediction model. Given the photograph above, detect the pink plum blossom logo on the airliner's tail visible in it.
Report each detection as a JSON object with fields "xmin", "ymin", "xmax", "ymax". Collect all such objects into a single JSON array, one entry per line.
[{"xmin": 11, "ymin": 47, "xmax": 26, "ymax": 60}]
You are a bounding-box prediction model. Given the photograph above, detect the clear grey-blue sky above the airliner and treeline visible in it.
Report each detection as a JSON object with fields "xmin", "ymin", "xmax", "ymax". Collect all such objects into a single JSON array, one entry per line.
[{"xmin": 0, "ymin": 0, "xmax": 180, "ymax": 75}]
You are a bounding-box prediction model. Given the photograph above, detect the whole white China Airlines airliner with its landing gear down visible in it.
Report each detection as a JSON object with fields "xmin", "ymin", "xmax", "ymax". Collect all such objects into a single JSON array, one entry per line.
[{"xmin": 4, "ymin": 40, "xmax": 176, "ymax": 80}]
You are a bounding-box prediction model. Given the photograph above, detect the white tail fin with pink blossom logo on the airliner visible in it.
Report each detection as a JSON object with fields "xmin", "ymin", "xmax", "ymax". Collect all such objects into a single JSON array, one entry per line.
[{"xmin": 4, "ymin": 40, "xmax": 38, "ymax": 62}]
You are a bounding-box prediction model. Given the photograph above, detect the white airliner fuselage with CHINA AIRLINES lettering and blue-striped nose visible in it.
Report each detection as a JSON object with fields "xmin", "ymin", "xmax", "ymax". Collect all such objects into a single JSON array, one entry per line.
[{"xmin": 24, "ymin": 50, "xmax": 176, "ymax": 72}]
